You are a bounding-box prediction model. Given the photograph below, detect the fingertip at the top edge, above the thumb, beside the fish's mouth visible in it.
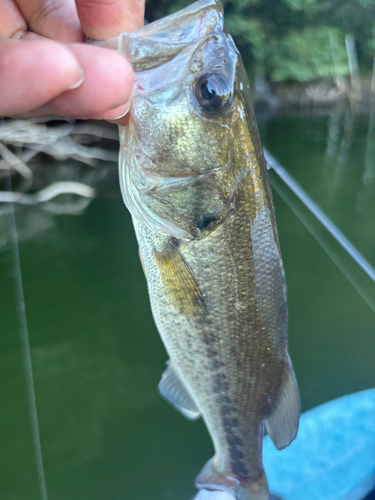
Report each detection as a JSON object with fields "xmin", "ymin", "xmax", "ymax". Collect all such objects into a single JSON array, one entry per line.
[{"xmin": 76, "ymin": 0, "xmax": 145, "ymax": 40}]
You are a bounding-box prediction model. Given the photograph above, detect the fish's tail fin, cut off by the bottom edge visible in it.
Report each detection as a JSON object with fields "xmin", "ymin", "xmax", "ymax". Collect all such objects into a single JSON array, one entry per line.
[{"xmin": 195, "ymin": 460, "xmax": 270, "ymax": 500}]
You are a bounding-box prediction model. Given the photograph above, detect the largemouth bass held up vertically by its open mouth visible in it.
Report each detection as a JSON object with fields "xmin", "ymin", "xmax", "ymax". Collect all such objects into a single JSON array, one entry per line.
[{"xmin": 119, "ymin": 0, "xmax": 300, "ymax": 500}]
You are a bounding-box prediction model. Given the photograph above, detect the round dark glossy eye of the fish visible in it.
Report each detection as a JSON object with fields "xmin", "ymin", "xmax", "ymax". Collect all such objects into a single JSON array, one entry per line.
[{"xmin": 195, "ymin": 74, "xmax": 231, "ymax": 113}]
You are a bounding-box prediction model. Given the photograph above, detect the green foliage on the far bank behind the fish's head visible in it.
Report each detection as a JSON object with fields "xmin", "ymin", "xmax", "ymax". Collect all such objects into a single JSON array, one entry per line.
[{"xmin": 146, "ymin": 0, "xmax": 375, "ymax": 81}]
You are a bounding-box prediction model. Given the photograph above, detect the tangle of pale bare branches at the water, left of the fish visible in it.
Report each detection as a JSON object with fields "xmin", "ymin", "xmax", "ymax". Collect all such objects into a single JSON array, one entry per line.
[{"xmin": 0, "ymin": 117, "xmax": 114, "ymax": 213}]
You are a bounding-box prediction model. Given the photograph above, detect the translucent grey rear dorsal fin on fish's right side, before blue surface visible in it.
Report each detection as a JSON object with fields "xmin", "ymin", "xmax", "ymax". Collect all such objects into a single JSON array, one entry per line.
[{"xmin": 266, "ymin": 353, "xmax": 301, "ymax": 450}]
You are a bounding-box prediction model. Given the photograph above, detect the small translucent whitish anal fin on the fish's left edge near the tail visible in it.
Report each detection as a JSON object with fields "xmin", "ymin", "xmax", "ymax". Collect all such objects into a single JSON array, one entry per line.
[{"xmin": 159, "ymin": 361, "xmax": 200, "ymax": 420}]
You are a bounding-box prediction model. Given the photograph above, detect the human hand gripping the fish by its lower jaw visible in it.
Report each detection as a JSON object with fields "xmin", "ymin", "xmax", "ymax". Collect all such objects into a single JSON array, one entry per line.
[{"xmin": 0, "ymin": 0, "xmax": 145, "ymax": 123}]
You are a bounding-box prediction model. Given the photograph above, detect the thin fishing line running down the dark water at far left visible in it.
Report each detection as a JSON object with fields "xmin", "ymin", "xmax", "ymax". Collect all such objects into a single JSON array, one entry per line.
[{"xmin": 6, "ymin": 170, "xmax": 48, "ymax": 500}]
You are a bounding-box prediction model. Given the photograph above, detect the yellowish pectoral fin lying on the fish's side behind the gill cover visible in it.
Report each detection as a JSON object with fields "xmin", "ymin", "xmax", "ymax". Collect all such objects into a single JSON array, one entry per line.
[{"xmin": 154, "ymin": 239, "xmax": 206, "ymax": 321}]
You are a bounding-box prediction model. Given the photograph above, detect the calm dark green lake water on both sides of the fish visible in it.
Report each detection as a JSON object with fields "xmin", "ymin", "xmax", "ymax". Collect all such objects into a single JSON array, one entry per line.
[{"xmin": 0, "ymin": 107, "xmax": 375, "ymax": 500}]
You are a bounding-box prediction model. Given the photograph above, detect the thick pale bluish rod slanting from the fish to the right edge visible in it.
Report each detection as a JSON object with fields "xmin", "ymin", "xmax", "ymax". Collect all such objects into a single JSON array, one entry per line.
[{"xmin": 264, "ymin": 148, "xmax": 375, "ymax": 282}]
